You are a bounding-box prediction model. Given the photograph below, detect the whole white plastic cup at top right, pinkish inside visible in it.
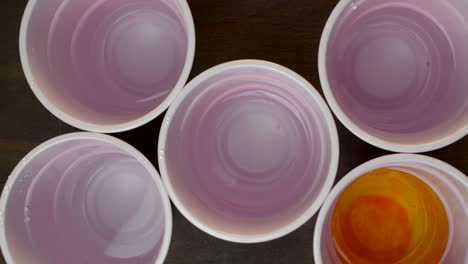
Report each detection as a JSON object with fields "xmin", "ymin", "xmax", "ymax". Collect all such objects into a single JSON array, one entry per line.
[{"xmin": 319, "ymin": 0, "xmax": 468, "ymax": 152}]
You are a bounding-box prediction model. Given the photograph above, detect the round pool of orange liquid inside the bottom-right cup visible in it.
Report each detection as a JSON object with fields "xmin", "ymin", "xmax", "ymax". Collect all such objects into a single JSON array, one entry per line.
[{"xmin": 332, "ymin": 169, "xmax": 449, "ymax": 264}]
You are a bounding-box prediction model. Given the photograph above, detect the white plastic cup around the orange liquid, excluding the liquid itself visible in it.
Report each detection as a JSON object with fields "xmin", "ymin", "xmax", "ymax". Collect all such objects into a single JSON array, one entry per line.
[{"xmin": 314, "ymin": 154, "xmax": 468, "ymax": 264}]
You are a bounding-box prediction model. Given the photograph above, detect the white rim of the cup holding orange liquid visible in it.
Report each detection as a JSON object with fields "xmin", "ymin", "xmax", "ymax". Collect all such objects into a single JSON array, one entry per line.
[{"xmin": 313, "ymin": 154, "xmax": 468, "ymax": 264}]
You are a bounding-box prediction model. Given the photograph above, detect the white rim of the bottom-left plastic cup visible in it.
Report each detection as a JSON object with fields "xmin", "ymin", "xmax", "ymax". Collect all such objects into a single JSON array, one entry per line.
[{"xmin": 0, "ymin": 132, "xmax": 172, "ymax": 264}]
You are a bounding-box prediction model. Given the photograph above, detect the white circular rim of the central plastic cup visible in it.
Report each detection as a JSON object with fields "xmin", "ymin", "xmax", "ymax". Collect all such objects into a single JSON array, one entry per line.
[{"xmin": 158, "ymin": 60, "xmax": 339, "ymax": 243}]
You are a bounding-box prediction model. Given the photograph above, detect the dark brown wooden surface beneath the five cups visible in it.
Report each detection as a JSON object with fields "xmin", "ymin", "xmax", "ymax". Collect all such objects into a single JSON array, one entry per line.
[{"xmin": 0, "ymin": 0, "xmax": 468, "ymax": 264}]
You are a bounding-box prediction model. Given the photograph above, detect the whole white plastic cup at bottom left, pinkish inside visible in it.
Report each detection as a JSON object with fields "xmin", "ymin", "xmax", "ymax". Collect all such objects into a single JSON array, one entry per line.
[{"xmin": 0, "ymin": 133, "xmax": 172, "ymax": 264}]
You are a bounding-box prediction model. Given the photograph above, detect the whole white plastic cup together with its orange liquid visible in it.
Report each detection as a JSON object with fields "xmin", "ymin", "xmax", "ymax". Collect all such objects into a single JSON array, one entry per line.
[{"xmin": 314, "ymin": 154, "xmax": 468, "ymax": 264}]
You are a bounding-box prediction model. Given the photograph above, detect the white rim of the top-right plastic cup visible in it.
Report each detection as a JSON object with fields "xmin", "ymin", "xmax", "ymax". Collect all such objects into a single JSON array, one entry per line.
[{"xmin": 318, "ymin": 0, "xmax": 468, "ymax": 153}]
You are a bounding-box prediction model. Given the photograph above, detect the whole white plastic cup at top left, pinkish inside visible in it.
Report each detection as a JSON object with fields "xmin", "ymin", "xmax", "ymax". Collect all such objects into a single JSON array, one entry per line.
[{"xmin": 20, "ymin": 0, "xmax": 195, "ymax": 133}]
